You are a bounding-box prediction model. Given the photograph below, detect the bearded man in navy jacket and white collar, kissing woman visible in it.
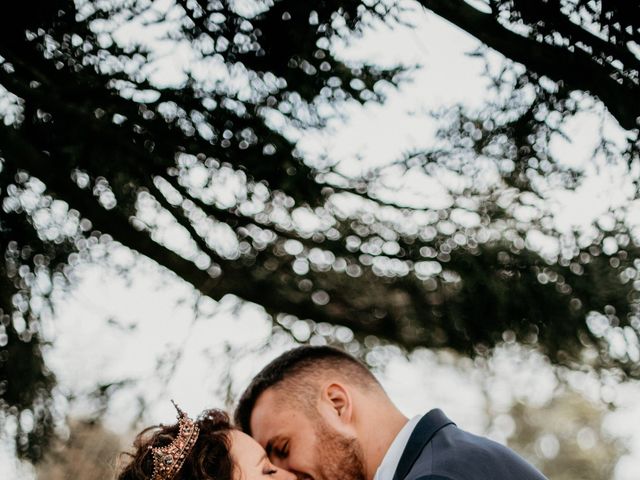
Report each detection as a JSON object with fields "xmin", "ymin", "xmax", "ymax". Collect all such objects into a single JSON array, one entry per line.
[{"xmin": 235, "ymin": 346, "xmax": 545, "ymax": 480}]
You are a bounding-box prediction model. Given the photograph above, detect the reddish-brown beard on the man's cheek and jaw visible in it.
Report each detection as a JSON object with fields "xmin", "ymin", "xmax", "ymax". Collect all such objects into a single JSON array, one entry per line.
[{"xmin": 315, "ymin": 419, "xmax": 365, "ymax": 480}]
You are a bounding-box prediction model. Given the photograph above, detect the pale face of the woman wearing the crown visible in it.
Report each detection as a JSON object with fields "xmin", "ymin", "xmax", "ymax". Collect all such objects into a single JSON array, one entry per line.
[{"xmin": 230, "ymin": 430, "xmax": 296, "ymax": 480}]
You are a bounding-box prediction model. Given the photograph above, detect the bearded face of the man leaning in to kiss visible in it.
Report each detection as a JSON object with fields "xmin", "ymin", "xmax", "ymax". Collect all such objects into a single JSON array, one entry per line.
[{"xmin": 251, "ymin": 389, "xmax": 365, "ymax": 480}]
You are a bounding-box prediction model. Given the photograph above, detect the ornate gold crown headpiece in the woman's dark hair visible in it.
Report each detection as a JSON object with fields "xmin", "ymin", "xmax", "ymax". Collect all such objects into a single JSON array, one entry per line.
[{"xmin": 149, "ymin": 400, "xmax": 200, "ymax": 480}]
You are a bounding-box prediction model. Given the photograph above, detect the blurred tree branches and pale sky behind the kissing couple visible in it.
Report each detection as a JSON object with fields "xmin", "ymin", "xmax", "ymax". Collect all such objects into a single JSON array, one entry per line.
[{"xmin": 0, "ymin": 0, "xmax": 640, "ymax": 480}]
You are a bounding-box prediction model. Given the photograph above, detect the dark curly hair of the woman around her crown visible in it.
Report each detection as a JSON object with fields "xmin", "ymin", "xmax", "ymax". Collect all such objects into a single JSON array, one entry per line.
[{"xmin": 117, "ymin": 409, "xmax": 234, "ymax": 480}]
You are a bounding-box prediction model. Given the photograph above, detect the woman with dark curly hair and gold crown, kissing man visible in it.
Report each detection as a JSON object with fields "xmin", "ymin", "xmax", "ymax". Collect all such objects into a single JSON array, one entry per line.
[{"xmin": 118, "ymin": 404, "xmax": 296, "ymax": 480}]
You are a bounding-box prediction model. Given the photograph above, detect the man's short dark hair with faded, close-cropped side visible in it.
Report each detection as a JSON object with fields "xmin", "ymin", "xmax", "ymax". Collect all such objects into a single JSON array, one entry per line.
[{"xmin": 234, "ymin": 345, "xmax": 382, "ymax": 435}]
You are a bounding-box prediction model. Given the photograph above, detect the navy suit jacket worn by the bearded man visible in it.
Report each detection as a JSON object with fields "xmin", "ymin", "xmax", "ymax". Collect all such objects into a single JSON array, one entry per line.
[{"xmin": 393, "ymin": 409, "xmax": 546, "ymax": 480}]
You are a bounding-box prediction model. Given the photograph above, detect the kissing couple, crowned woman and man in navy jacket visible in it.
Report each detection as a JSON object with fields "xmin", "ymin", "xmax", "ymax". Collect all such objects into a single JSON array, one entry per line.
[{"xmin": 117, "ymin": 346, "xmax": 545, "ymax": 480}]
